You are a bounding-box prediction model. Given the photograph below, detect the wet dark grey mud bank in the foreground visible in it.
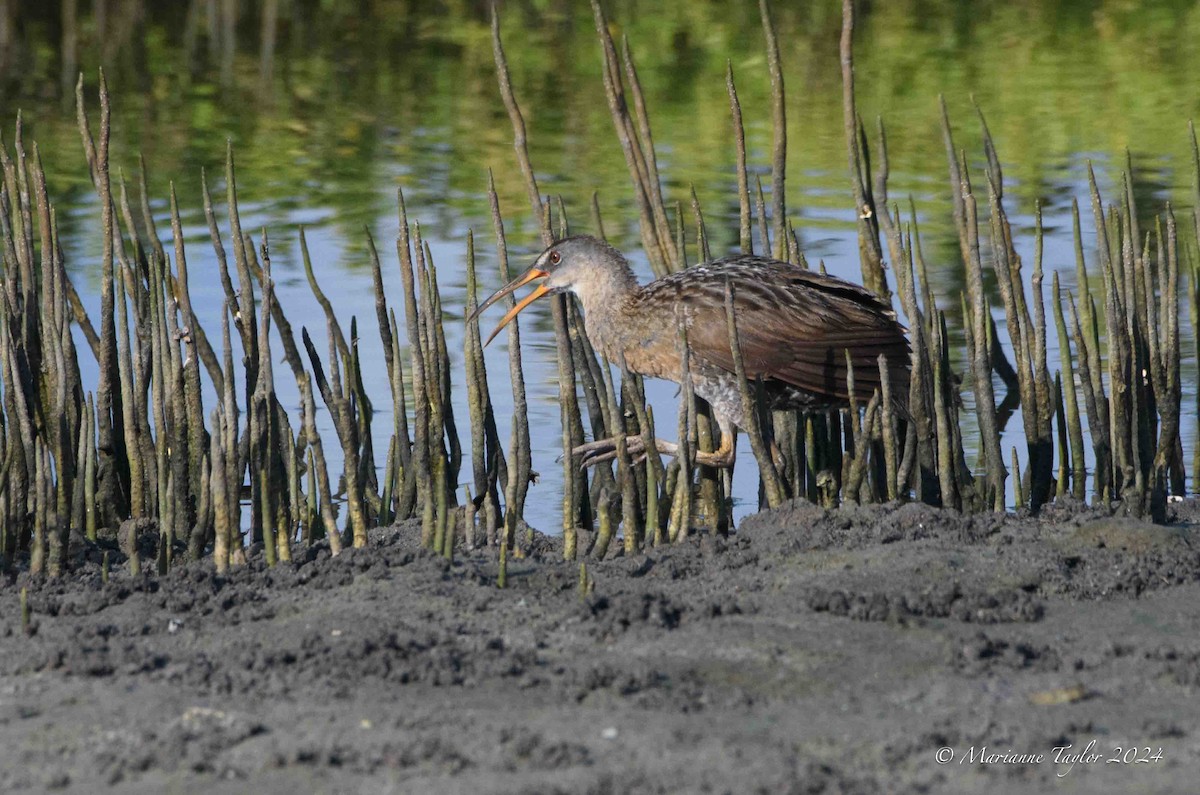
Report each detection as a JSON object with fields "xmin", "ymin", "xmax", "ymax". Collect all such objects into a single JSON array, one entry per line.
[{"xmin": 0, "ymin": 503, "xmax": 1200, "ymax": 793}]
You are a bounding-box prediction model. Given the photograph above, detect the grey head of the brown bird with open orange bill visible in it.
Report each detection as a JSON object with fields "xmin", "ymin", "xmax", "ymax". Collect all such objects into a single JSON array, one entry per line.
[{"xmin": 469, "ymin": 235, "xmax": 634, "ymax": 345}]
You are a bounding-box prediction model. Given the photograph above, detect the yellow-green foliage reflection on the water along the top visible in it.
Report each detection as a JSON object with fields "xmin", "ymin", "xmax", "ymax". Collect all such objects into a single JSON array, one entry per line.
[{"xmin": 7, "ymin": 0, "xmax": 1200, "ymax": 249}]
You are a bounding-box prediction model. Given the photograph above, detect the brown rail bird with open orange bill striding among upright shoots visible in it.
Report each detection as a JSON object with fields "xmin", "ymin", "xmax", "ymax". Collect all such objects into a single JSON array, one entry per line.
[{"xmin": 468, "ymin": 235, "xmax": 911, "ymax": 467}]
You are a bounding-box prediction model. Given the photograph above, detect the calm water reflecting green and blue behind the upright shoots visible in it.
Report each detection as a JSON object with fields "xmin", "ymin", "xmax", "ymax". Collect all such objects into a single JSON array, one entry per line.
[{"xmin": 0, "ymin": 0, "xmax": 1200, "ymax": 530}]
